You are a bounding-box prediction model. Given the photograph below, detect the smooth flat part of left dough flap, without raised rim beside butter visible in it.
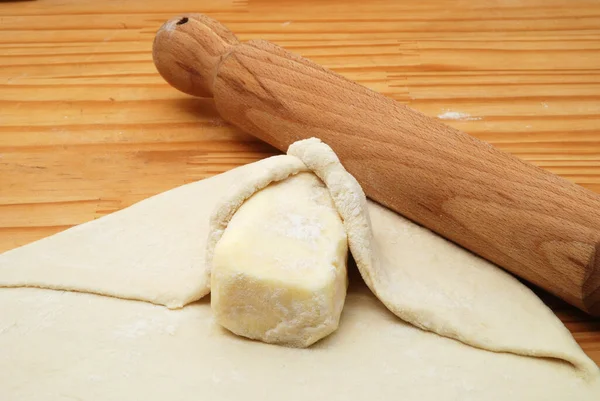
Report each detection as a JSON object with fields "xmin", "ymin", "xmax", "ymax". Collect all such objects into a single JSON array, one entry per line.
[{"xmin": 0, "ymin": 166, "xmax": 248, "ymax": 308}]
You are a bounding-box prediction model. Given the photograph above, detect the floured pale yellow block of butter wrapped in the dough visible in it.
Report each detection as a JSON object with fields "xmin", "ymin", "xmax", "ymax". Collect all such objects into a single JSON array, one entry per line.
[{"xmin": 211, "ymin": 172, "xmax": 348, "ymax": 347}]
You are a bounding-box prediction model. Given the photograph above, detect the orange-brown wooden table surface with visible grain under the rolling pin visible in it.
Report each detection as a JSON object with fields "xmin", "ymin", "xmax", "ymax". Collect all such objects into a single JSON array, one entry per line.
[{"xmin": 0, "ymin": 0, "xmax": 600, "ymax": 364}]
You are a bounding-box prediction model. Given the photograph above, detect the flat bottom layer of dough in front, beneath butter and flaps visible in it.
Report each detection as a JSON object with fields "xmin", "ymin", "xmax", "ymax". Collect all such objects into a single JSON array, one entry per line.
[{"xmin": 0, "ymin": 283, "xmax": 600, "ymax": 401}]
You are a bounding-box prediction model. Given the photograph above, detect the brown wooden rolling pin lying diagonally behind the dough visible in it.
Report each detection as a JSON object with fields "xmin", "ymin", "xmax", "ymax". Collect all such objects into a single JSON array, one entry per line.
[{"xmin": 153, "ymin": 14, "xmax": 600, "ymax": 316}]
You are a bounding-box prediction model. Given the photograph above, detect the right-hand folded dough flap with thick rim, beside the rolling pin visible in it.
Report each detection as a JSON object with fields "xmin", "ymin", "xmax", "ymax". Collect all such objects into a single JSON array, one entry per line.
[{"xmin": 288, "ymin": 138, "xmax": 599, "ymax": 377}]
